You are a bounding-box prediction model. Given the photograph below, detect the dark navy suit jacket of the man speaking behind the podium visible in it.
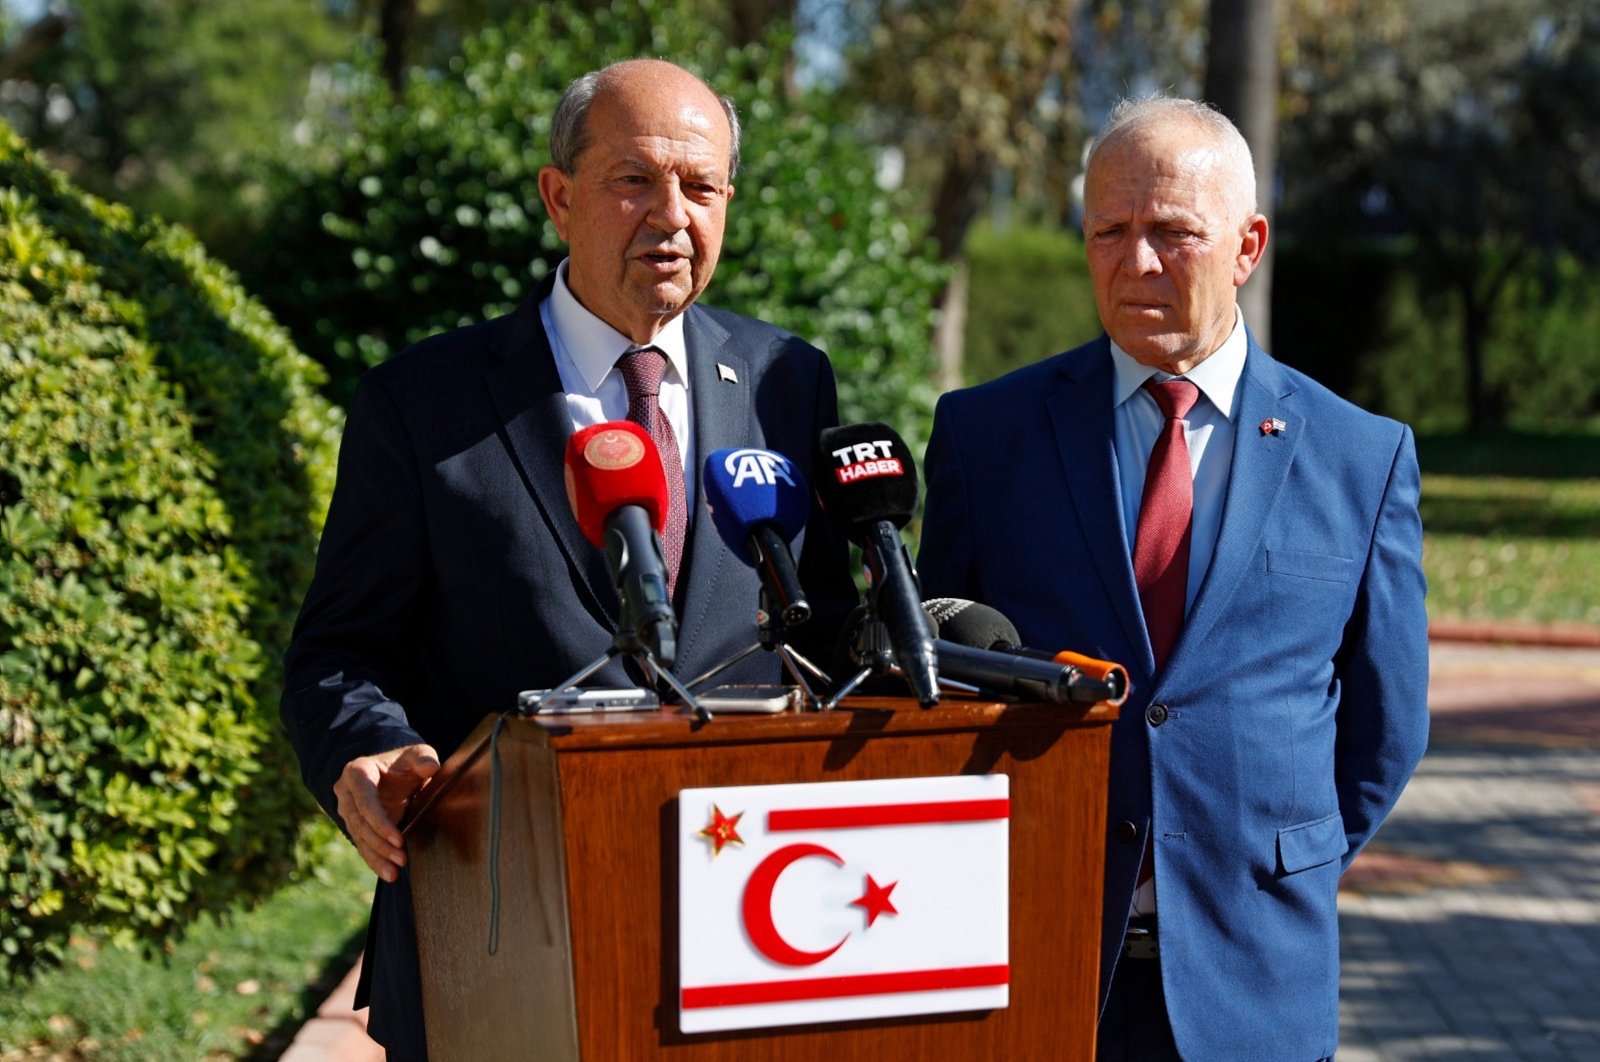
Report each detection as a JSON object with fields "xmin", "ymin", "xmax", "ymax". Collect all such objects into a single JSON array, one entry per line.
[{"xmin": 282, "ymin": 281, "xmax": 856, "ymax": 1057}]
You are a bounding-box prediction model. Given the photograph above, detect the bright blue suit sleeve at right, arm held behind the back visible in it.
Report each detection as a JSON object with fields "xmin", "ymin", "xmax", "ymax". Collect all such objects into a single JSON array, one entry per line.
[{"xmin": 1334, "ymin": 427, "xmax": 1429, "ymax": 865}]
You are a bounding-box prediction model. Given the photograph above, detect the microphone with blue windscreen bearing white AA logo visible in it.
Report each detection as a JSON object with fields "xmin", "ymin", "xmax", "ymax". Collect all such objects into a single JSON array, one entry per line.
[{"xmin": 701, "ymin": 446, "xmax": 811, "ymax": 627}]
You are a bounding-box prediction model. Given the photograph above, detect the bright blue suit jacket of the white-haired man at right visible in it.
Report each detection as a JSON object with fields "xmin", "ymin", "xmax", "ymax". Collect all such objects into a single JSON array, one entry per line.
[{"xmin": 918, "ymin": 336, "xmax": 1427, "ymax": 1059}]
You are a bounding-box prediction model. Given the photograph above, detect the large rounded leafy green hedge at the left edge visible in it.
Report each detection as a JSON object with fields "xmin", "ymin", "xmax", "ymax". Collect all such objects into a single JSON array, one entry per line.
[{"xmin": 0, "ymin": 125, "xmax": 338, "ymax": 976}]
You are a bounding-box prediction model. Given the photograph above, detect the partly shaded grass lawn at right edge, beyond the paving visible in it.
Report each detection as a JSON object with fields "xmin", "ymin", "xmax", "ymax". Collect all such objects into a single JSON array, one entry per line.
[{"xmin": 1418, "ymin": 433, "xmax": 1600, "ymax": 625}]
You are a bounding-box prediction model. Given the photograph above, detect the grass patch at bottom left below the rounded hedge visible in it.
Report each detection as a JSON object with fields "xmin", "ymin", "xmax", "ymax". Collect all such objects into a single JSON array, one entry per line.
[{"xmin": 0, "ymin": 840, "xmax": 373, "ymax": 1062}]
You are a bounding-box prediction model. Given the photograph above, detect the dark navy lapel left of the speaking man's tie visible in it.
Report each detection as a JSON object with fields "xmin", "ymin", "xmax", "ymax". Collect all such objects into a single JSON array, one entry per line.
[{"xmin": 485, "ymin": 286, "xmax": 618, "ymax": 627}]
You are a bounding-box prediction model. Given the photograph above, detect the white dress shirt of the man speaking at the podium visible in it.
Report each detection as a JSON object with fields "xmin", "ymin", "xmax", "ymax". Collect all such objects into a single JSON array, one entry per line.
[{"xmin": 539, "ymin": 259, "xmax": 696, "ymax": 505}]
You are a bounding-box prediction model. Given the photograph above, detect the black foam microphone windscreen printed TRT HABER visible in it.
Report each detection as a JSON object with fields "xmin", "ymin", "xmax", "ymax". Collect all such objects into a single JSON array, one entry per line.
[{"xmin": 816, "ymin": 421, "xmax": 917, "ymax": 528}]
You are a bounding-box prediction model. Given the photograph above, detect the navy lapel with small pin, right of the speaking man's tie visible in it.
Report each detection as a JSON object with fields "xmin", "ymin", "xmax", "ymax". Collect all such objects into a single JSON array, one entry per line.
[{"xmin": 677, "ymin": 307, "xmax": 760, "ymax": 665}]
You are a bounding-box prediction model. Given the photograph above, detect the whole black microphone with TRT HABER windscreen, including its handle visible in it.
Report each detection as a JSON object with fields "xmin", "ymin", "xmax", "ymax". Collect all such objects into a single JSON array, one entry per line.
[{"xmin": 818, "ymin": 422, "xmax": 939, "ymax": 707}]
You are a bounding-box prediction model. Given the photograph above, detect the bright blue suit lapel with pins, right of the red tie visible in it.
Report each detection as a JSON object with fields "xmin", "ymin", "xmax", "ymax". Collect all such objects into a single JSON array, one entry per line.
[{"xmin": 1168, "ymin": 337, "xmax": 1306, "ymax": 665}]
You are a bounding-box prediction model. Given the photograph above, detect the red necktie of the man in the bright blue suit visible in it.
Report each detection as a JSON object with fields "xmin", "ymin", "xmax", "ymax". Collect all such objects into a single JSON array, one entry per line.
[{"xmin": 1133, "ymin": 379, "xmax": 1200, "ymax": 672}]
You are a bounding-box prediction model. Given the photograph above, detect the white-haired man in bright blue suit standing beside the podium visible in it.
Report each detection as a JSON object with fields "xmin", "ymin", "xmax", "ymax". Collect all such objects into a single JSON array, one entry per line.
[{"xmin": 918, "ymin": 99, "xmax": 1427, "ymax": 1062}]
